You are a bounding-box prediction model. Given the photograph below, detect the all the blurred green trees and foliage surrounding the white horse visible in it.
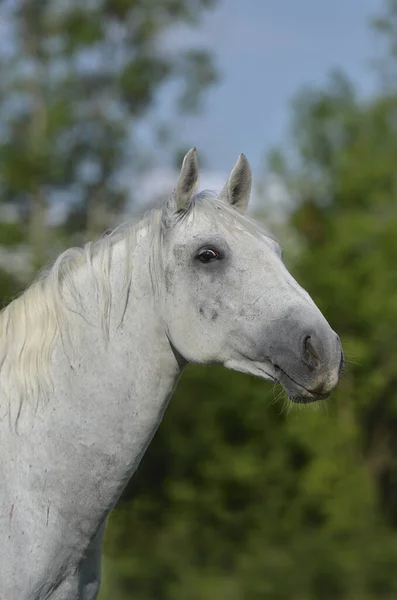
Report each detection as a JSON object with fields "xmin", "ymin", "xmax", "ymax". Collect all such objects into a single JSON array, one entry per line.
[{"xmin": 0, "ymin": 0, "xmax": 397, "ymax": 600}]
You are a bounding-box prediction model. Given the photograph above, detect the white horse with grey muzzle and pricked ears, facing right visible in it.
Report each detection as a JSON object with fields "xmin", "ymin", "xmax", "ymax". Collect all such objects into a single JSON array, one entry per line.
[{"xmin": 0, "ymin": 149, "xmax": 343, "ymax": 600}]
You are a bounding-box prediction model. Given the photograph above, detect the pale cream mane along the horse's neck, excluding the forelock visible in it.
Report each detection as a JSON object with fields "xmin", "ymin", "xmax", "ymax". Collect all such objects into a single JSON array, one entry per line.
[{"xmin": 0, "ymin": 210, "xmax": 160, "ymax": 417}]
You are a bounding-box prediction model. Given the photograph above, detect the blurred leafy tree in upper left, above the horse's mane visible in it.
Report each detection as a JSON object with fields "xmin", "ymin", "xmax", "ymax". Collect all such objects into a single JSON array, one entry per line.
[{"xmin": 0, "ymin": 0, "xmax": 215, "ymax": 268}]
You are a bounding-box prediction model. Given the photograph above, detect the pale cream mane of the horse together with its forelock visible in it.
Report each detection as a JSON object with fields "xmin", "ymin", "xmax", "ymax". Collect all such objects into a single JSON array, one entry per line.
[{"xmin": 0, "ymin": 191, "xmax": 270, "ymax": 417}]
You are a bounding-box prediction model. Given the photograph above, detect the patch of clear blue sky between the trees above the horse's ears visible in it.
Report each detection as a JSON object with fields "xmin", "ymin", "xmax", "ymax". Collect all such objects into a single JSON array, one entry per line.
[{"xmin": 148, "ymin": 0, "xmax": 383, "ymax": 176}]
